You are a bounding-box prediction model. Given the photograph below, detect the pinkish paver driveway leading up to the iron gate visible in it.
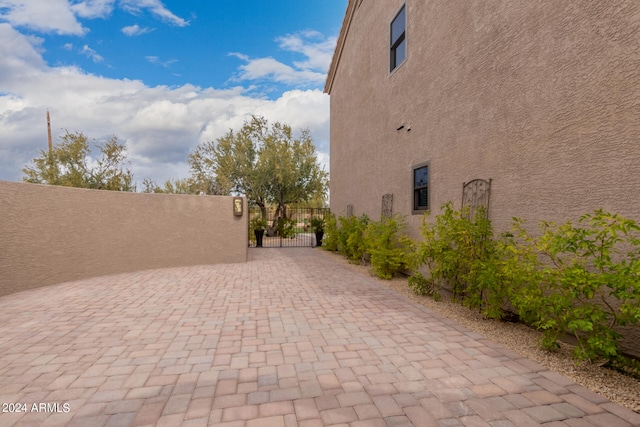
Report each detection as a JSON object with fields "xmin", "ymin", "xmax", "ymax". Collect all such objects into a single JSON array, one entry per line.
[{"xmin": 0, "ymin": 248, "xmax": 640, "ymax": 427}]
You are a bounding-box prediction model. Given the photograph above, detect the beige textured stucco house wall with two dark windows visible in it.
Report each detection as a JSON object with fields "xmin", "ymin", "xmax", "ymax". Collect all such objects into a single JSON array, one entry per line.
[{"xmin": 325, "ymin": 0, "xmax": 640, "ymax": 358}]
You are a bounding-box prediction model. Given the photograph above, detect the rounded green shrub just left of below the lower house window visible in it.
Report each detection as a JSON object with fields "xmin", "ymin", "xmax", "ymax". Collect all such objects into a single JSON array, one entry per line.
[{"xmin": 364, "ymin": 215, "xmax": 414, "ymax": 279}]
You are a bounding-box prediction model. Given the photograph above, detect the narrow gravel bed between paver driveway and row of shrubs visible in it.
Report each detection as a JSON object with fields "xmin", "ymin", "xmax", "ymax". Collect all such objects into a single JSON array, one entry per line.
[{"xmin": 321, "ymin": 251, "xmax": 640, "ymax": 413}]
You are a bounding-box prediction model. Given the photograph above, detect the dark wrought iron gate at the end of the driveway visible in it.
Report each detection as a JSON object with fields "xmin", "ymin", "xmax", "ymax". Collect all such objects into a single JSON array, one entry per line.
[{"xmin": 249, "ymin": 207, "xmax": 330, "ymax": 248}]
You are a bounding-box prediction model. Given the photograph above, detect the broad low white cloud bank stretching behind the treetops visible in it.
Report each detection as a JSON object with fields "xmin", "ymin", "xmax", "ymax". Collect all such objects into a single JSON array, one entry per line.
[{"xmin": 0, "ymin": 24, "xmax": 329, "ymax": 186}]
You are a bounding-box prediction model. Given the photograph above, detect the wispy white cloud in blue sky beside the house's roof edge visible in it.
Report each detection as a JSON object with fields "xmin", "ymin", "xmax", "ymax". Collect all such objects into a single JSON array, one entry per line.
[{"xmin": 230, "ymin": 31, "xmax": 336, "ymax": 86}]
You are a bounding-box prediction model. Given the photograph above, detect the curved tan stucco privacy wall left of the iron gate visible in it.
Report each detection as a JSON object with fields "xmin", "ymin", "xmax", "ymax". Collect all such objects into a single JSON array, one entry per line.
[{"xmin": 0, "ymin": 181, "xmax": 248, "ymax": 295}]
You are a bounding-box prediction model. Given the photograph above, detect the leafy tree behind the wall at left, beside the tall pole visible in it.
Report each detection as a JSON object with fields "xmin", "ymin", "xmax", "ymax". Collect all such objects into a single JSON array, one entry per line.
[{"xmin": 22, "ymin": 131, "xmax": 135, "ymax": 191}]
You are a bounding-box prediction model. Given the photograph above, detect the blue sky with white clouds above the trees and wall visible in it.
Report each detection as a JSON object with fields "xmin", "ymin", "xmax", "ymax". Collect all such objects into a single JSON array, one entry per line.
[{"xmin": 0, "ymin": 0, "xmax": 347, "ymax": 183}]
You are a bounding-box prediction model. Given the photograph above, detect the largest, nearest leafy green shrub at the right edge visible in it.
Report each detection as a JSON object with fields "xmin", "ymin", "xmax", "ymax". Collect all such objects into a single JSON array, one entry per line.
[{"xmin": 505, "ymin": 210, "xmax": 640, "ymax": 361}]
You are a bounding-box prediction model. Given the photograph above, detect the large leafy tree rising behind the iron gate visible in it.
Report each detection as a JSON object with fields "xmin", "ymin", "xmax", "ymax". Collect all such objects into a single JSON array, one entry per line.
[{"xmin": 189, "ymin": 116, "xmax": 327, "ymax": 233}]
